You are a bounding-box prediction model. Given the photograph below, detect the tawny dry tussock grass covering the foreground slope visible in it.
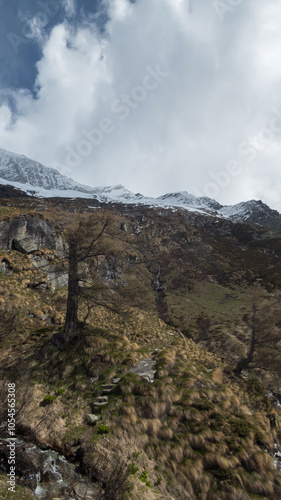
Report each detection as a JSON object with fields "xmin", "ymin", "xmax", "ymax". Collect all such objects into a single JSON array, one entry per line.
[{"xmin": 0, "ymin": 203, "xmax": 281, "ymax": 500}]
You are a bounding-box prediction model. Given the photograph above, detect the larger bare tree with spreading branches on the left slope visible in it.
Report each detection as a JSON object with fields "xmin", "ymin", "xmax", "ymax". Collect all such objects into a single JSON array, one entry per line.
[{"xmin": 50, "ymin": 213, "xmax": 158, "ymax": 348}]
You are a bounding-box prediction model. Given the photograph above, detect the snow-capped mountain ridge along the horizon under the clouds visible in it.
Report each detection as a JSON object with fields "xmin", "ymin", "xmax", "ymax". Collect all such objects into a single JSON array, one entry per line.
[{"xmin": 0, "ymin": 149, "xmax": 281, "ymax": 229}]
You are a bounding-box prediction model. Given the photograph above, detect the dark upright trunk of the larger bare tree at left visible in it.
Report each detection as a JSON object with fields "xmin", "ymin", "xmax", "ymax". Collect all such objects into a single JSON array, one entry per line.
[{"xmin": 64, "ymin": 241, "xmax": 79, "ymax": 342}]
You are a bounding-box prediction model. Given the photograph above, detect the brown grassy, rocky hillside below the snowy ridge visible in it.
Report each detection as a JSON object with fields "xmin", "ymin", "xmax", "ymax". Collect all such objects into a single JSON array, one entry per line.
[{"xmin": 0, "ymin": 192, "xmax": 281, "ymax": 500}]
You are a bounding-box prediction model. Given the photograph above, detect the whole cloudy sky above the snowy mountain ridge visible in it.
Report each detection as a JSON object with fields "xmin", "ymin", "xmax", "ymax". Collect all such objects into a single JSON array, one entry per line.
[{"xmin": 0, "ymin": 0, "xmax": 281, "ymax": 212}]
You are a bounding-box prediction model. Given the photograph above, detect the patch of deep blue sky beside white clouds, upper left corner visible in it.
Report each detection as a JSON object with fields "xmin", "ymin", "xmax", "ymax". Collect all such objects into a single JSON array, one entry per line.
[{"xmin": 0, "ymin": 0, "xmax": 106, "ymax": 91}]
